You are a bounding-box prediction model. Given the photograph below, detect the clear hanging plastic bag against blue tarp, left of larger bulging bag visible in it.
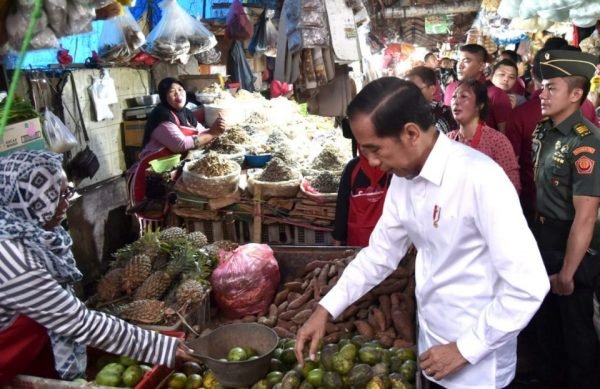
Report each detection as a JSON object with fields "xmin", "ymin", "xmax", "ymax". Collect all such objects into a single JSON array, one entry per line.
[{"xmin": 98, "ymin": 8, "xmax": 146, "ymax": 62}]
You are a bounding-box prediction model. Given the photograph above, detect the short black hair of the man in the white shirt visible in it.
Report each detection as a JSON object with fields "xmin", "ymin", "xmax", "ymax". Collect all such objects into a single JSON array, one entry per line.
[{"xmin": 347, "ymin": 77, "xmax": 433, "ymax": 138}]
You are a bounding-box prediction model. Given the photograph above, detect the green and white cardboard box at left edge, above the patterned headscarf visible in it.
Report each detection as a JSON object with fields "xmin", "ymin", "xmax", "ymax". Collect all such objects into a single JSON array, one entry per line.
[{"xmin": 0, "ymin": 118, "xmax": 46, "ymax": 157}]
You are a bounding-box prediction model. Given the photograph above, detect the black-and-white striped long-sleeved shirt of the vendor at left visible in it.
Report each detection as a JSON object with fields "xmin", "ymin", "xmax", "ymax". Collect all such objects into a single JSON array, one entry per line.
[{"xmin": 0, "ymin": 240, "xmax": 179, "ymax": 367}]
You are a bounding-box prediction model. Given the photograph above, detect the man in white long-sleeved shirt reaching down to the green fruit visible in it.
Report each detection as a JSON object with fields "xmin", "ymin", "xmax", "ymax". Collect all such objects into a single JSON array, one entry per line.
[{"xmin": 296, "ymin": 78, "xmax": 549, "ymax": 389}]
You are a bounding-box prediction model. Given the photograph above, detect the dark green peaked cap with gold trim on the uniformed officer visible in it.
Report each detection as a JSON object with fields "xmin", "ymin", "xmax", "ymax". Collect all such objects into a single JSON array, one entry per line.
[{"xmin": 540, "ymin": 50, "xmax": 598, "ymax": 80}]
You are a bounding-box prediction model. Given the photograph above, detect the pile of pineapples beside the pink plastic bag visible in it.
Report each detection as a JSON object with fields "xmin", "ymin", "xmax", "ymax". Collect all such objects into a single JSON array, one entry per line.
[{"xmin": 95, "ymin": 227, "xmax": 233, "ymax": 326}]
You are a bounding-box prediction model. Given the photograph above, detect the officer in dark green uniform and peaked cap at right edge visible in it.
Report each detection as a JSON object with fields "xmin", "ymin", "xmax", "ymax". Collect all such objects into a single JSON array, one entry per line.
[{"xmin": 533, "ymin": 50, "xmax": 600, "ymax": 388}]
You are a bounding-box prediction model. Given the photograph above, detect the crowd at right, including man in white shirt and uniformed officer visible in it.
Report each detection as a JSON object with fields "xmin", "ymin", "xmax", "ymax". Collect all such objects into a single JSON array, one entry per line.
[{"xmin": 304, "ymin": 38, "xmax": 600, "ymax": 388}]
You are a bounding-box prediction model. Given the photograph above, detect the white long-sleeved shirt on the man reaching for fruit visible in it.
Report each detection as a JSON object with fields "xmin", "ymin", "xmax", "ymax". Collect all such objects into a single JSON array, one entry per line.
[{"xmin": 320, "ymin": 135, "xmax": 549, "ymax": 389}]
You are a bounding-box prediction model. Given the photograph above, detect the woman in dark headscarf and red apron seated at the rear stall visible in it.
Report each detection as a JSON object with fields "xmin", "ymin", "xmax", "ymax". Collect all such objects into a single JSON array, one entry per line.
[{"xmin": 130, "ymin": 77, "xmax": 225, "ymax": 214}]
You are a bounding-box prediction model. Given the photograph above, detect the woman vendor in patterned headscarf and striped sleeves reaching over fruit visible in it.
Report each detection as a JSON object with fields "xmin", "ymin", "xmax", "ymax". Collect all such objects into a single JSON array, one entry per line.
[{"xmin": 0, "ymin": 151, "xmax": 197, "ymax": 387}]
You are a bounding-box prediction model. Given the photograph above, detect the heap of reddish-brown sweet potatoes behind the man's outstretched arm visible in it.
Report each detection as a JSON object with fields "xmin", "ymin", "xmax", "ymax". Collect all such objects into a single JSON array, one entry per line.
[{"xmin": 260, "ymin": 252, "xmax": 415, "ymax": 347}]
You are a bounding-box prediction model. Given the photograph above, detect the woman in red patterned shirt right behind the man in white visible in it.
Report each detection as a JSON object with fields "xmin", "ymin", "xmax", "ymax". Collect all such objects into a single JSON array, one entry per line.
[{"xmin": 448, "ymin": 80, "xmax": 521, "ymax": 192}]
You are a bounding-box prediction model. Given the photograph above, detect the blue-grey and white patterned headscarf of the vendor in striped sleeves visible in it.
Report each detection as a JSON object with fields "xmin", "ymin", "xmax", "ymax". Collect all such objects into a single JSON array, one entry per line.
[{"xmin": 0, "ymin": 150, "xmax": 86, "ymax": 379}]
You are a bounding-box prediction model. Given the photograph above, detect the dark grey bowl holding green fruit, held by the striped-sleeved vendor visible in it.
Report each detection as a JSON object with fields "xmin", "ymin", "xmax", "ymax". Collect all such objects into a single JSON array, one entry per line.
[{"xmin": 187, "ymin": 323, "xmax": 279, "ymax": 387}]
